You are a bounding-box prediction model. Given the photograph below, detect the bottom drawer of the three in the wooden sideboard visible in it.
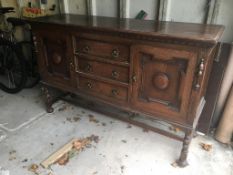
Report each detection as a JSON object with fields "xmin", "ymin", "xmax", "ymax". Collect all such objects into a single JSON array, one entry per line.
[{"xmin": 77, "ymin": 75, "xmax": 128, "ymax": 102}]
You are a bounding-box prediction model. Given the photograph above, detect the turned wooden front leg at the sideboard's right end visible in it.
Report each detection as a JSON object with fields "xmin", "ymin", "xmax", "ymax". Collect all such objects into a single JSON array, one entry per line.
[{"xmin": 176, "ymin": 131, "xmax": 193, "ymax": 168}]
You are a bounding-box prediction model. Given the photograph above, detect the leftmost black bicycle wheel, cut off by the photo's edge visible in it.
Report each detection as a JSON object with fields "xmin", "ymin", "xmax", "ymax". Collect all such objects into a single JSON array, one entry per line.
[{"xmin": 0, "ymin": 38, "xmax": 27, "ymax": 93}]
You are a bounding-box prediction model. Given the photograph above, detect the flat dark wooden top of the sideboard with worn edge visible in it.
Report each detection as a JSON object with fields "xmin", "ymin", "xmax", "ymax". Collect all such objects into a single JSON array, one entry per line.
[{"xmin": 25, "ymin": 14, "xmax": 224, "ymax": 44}]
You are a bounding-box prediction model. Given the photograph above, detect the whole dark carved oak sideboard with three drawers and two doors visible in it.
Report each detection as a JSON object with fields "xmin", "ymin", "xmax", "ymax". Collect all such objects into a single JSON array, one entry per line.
[{"xmin": 25, "ymin": 15, "xmax": 224, "ymax": 167}]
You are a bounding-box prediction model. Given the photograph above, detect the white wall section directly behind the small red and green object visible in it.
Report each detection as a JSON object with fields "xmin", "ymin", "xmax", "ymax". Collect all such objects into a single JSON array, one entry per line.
[{"xmin": 129, "ymin": 0, "xmax": 158, "ymax": 20}]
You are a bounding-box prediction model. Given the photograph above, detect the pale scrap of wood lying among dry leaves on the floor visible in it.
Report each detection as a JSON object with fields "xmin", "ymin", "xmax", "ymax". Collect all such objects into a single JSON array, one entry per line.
[{"xmin": 41, "ymin": 139, "xmax": 77, "ymax": 168}]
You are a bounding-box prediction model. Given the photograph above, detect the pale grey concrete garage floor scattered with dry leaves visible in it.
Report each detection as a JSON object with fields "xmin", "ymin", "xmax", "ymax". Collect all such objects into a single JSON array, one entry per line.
[{"xmin": 0, "ymin": 88, "xmax": 233, "ymax": 175}]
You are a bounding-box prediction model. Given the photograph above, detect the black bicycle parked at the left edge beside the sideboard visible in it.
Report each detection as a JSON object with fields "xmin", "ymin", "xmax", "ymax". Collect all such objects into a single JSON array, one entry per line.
[{"xmin": 0, "ymin": 7, "xmax": 40, "ymax": 93}]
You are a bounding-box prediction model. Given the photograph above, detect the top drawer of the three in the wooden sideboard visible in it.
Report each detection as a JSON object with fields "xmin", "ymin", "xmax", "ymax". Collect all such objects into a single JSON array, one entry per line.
[{"xmin": 75, "ymin": 38, "xmax": 130, "ymax": 62}]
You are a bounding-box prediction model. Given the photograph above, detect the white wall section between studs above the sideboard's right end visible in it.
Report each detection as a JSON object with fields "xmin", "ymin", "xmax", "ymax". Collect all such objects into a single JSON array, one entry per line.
[{"xmin": 166, "ymin": 0, "xmax": 207, "ymax": 23}]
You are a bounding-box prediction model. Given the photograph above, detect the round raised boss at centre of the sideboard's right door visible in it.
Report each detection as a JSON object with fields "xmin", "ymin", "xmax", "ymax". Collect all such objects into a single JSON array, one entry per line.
[{"xmin": 152, "ymin": 72, "xmax": 169, "ymax": 90}]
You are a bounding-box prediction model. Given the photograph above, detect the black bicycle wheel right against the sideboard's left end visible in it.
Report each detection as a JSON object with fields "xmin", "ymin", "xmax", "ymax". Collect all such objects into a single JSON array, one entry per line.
[{"xmin": 18, "ymin": 41, "xmax": 40, "ymax": 88}]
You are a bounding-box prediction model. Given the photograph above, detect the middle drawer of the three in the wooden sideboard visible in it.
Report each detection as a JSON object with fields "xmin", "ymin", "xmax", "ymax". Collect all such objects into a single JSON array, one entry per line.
[{"xmin": 76, "ymin": 57, "xmax": 129, "ymax": 83}]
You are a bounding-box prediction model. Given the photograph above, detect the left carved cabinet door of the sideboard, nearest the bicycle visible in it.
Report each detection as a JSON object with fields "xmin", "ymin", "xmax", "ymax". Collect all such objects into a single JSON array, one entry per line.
[{"xmin": 36, "ymin": 32, "xmax": 73, "ymax": 87}]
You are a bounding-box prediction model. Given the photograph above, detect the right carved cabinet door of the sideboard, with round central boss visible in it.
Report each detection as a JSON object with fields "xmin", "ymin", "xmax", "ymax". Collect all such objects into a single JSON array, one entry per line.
[{"xmin": 131, "ymin": 45, "xmax": 196, "ymax": 122}]
